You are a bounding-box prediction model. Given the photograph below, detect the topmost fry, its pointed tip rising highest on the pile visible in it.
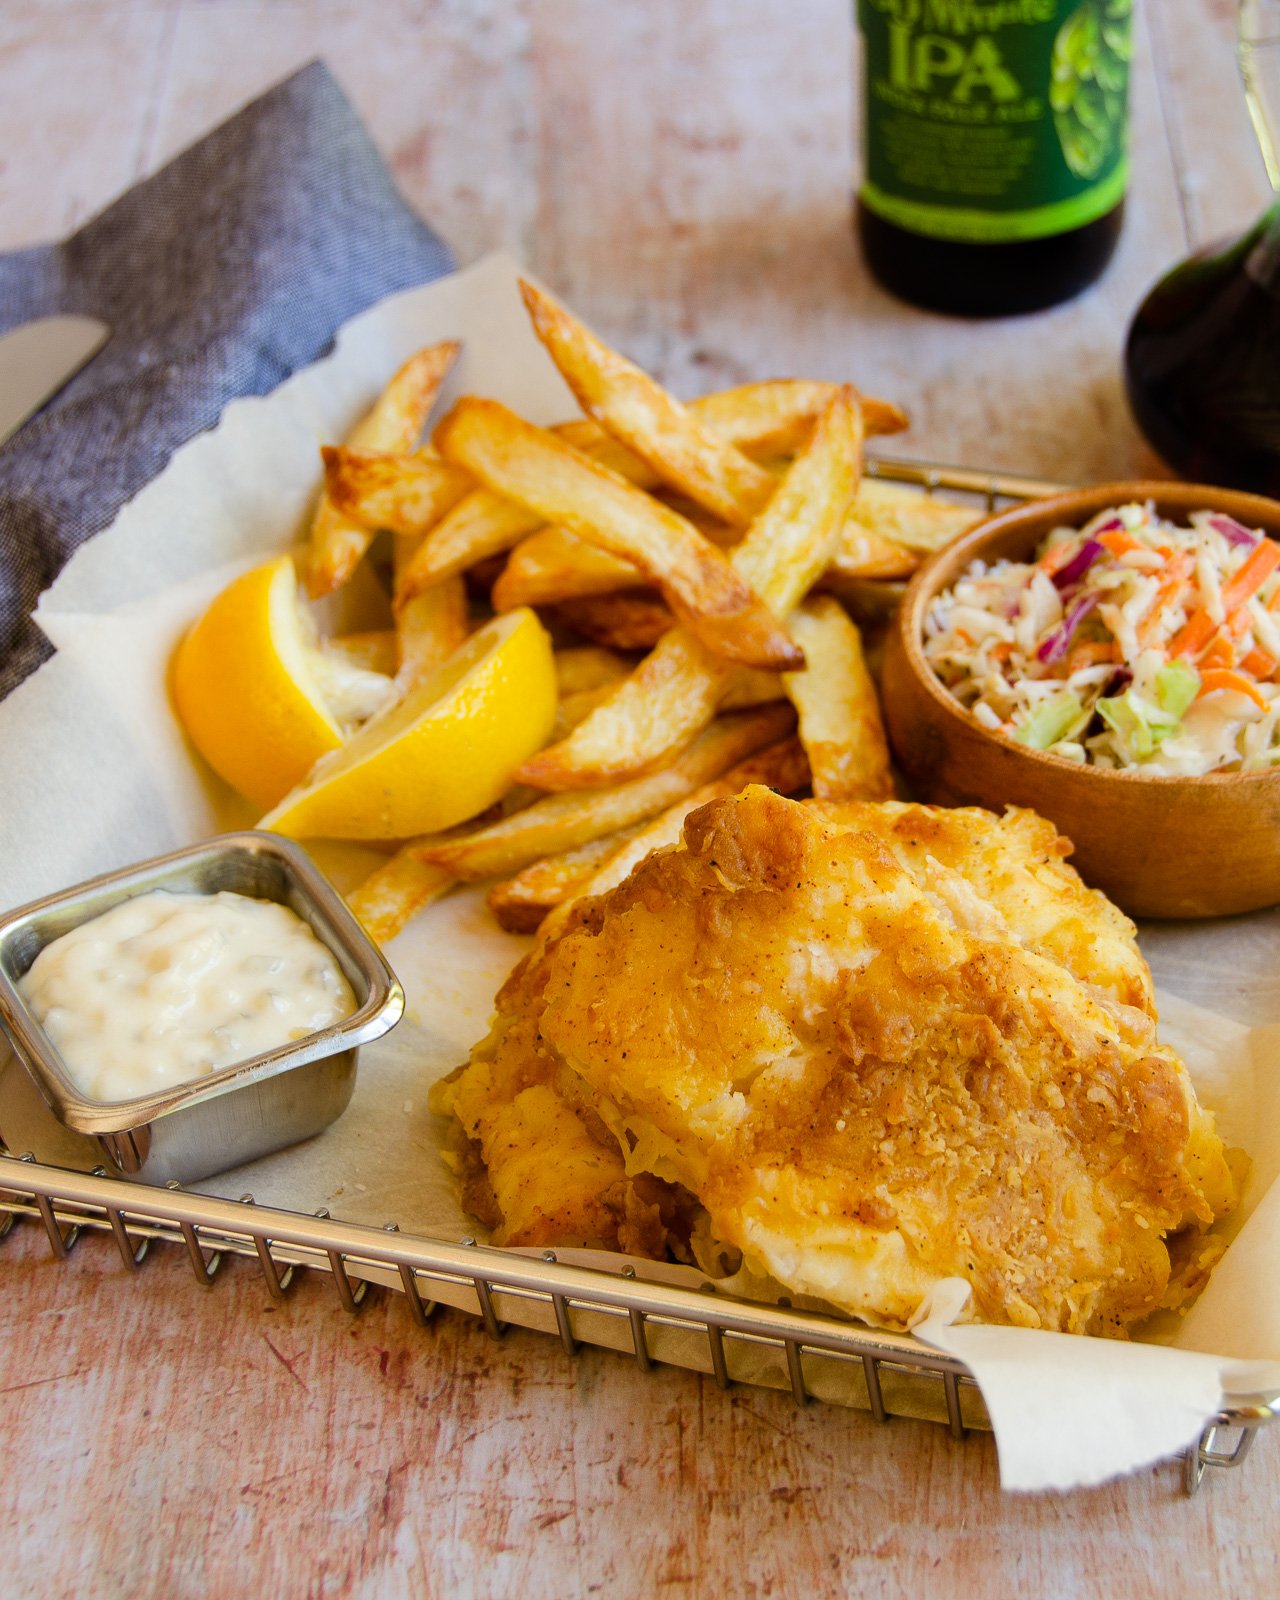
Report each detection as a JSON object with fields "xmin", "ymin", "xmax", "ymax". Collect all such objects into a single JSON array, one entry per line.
[{"xmin": 520, "ymin": 278, "xmax": 776, "ymax": 521}]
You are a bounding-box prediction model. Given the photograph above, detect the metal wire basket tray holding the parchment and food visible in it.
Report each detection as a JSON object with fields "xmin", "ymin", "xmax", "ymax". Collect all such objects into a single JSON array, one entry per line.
[{"xmin": 0, "ymin": 458, "xmax": 1280, "ymax": 1494}]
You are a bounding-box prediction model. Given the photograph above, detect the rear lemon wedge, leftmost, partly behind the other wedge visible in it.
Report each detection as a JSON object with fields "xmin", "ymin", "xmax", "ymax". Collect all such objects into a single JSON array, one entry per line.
[{"xmin": 171, "ymin": 555, "xmax": 364, "ymax": 806}]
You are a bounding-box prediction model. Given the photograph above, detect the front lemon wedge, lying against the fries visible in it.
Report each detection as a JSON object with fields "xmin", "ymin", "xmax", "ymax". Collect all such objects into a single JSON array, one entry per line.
[{"xmin": 258, "ymin": 606, "xmax": 555, "ymax": 838}]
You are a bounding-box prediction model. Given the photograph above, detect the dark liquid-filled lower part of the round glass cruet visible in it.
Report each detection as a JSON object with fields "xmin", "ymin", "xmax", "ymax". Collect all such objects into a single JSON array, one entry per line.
[{"xmin": 1125, "ymin": 202, "xmax": 1280, "ymax": 494}]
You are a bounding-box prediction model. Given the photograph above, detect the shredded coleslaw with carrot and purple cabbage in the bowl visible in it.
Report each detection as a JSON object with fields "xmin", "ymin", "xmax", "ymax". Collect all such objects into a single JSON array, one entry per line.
[{"xmin": 923, "ymin": 502, "xmax": 1280, "ymax": 778}]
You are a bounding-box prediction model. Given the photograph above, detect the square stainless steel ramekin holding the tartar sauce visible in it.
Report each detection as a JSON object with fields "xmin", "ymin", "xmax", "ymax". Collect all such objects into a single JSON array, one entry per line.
[{"xmin": 0, "ymin": 832, "xmax": 405, "ymax": 1184}]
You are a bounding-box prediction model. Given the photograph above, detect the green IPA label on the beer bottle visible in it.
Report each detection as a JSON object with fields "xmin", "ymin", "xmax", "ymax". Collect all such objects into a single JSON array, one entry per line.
[{"xmin": 858, "ymin": 0, "xmax": 1133, "ymax": 243}]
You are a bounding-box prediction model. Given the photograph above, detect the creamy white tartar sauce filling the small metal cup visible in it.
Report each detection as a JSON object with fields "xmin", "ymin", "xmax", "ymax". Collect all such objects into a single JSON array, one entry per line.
[{"xmin": 21, "ymin": 890, "xmax": 355, "ymax": 1101}]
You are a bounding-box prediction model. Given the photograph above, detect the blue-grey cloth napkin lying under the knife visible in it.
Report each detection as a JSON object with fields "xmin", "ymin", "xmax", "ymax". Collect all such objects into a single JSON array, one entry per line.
[{"xmin": 0, "ymin": 62, "xmax": 453, "ymax": 696}]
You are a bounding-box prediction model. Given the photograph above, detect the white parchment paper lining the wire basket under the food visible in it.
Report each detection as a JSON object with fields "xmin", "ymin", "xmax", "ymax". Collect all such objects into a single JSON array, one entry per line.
[{"xmin": 0, "ymin": 256, "xmax": 1280, "ymax": 1488}]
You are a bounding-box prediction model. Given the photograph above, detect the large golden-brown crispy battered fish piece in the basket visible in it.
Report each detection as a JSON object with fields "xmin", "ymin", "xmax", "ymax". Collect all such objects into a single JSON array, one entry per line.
[{"xmin": 438, "ymin": 789, "xmax": 1235, "ymax": 1334}]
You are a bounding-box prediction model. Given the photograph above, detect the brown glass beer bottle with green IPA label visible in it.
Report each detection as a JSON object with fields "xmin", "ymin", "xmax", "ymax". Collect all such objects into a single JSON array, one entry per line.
[{"xmin": 858, "ymin": 0, "xmax": 1131, "ymax": 317}]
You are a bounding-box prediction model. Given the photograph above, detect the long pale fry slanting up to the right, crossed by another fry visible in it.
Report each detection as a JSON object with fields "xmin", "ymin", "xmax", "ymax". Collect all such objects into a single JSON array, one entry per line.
[{"xmin": 518, "ymin": 390, "xmax": 862, "ymax": 789}]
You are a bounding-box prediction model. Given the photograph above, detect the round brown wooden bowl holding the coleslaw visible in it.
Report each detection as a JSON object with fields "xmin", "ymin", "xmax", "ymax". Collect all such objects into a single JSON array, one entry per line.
[{"xmin": 883, "ymin": 482, "xmax": 1280, "ymax": 917}]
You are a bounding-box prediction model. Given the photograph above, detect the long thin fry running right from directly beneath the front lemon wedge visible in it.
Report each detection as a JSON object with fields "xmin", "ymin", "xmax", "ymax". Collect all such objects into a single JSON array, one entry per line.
[{"xmin": 410, "ymin": 706, "xmax": 795, "ymax": 880}]
